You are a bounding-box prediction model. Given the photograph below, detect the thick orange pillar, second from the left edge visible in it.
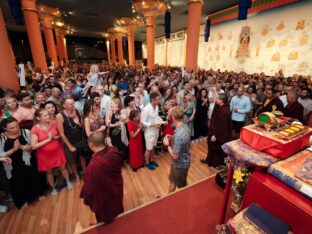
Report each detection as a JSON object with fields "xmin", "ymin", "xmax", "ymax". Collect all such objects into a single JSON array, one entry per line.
[{"xmin": 22, "ymin": 0, "xmax": 48, "ymax": 71}]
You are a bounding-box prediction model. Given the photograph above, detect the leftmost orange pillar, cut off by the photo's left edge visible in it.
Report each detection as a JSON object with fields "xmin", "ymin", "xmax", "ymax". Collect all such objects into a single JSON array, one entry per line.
[{"xmin": 0, "ymin": 8, "xmax": 19, "ymax": 91}]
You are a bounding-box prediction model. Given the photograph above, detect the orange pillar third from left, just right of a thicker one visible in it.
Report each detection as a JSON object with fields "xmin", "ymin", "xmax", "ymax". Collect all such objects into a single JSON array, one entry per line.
[{"xmin": 41, "ymin": 19, "xmax": 59, "ymax": 67}]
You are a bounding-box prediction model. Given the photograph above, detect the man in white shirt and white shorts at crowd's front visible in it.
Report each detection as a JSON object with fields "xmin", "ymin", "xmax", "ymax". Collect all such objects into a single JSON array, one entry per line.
[{"xmin": 141, "ymin": 92, "xmax": 161, "ymax": 170}]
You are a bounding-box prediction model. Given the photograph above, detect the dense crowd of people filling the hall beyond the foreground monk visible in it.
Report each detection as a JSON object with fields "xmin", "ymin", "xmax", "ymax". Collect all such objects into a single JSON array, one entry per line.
[{"xmin": 0, "ymin": 63, "xmax": 312, "ymax": 219}]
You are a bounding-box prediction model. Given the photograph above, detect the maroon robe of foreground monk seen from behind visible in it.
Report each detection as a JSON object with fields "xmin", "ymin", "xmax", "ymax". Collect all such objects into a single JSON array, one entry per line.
[{"xmin": 80, "ymin": 147, "xmax": 124, "ymax": 223}]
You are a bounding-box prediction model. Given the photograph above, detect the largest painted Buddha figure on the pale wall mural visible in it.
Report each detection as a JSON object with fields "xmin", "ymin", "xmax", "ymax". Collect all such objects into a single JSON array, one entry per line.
[{"xmin": 236, "ymin": 26, "xmax": 251, "ymax": 64}]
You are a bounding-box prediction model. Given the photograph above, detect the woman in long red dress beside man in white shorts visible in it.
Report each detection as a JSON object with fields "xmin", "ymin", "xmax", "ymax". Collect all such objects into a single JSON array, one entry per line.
[{"xmin": 127, "ymin": 110, "xmax": 143, "ymax": 172}]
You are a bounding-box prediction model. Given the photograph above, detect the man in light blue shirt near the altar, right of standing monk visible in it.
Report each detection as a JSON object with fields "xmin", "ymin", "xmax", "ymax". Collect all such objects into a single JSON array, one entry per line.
[{"xmin": 230, "ymin": 87, "xmax": 251, "ymax": 139}]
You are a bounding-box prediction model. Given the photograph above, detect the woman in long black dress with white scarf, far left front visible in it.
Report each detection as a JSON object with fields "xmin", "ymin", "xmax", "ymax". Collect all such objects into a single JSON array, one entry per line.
[{"xmin": 0, "ymin": 117, "xmax": 47, "ymax": 209}]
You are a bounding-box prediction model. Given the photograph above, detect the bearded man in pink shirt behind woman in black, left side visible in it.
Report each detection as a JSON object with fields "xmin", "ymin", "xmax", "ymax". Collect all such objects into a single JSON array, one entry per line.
[{"xmin": 13, "ymin": 92, "xmax": 36, "ymax": 130}]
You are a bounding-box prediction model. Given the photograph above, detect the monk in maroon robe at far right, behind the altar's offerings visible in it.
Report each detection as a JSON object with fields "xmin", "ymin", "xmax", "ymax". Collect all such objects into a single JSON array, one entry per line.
[{"xmin": 284, "ymin": 91, "xmax": 304, "ymax": 122}]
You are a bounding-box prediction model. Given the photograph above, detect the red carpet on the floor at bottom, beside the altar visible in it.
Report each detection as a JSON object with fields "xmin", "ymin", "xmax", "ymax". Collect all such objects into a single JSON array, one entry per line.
[{"xmin": 81, "ymin": 177, "xmax": 233, "ymax": 234}]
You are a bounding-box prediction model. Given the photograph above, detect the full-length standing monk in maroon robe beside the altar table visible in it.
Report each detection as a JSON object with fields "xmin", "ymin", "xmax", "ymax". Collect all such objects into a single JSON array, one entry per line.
[{"xmin": 201, "ymin": 94, "xmax": 232, "ymax": 168}]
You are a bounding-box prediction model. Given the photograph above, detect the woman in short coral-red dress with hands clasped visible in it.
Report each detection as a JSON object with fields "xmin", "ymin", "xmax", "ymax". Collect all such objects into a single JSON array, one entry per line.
[{"xmin": 30, "ymin": 109, "xmax": 72, "ymax": 196}]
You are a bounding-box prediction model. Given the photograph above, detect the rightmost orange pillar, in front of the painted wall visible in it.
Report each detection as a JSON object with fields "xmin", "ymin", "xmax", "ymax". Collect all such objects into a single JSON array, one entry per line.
[{"xmin": 185, "ymin": 0, "xmax": 204, "ymax": 71}]
